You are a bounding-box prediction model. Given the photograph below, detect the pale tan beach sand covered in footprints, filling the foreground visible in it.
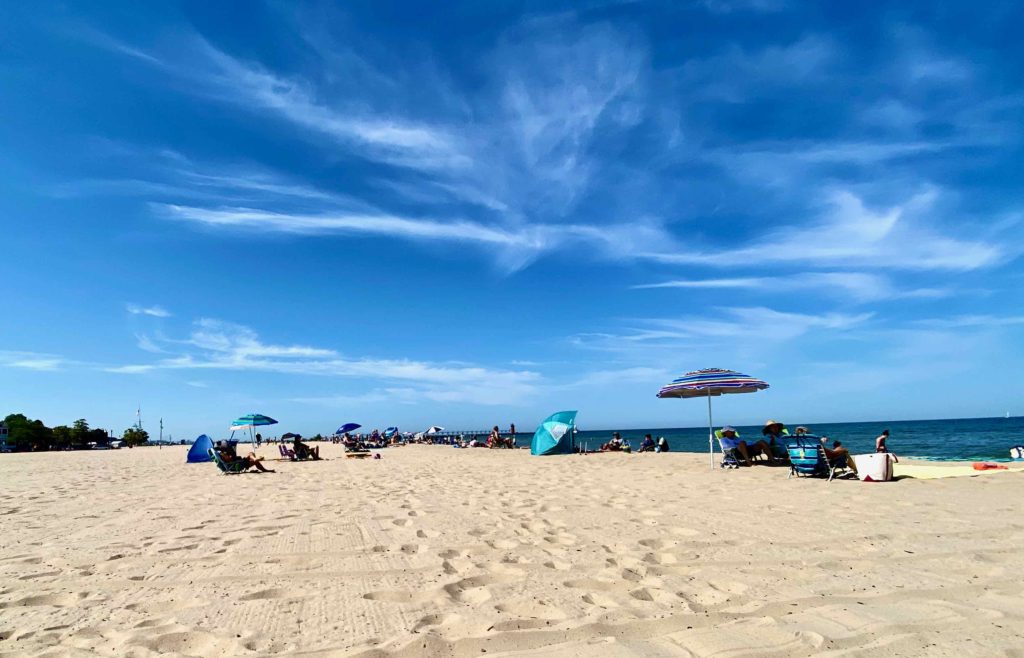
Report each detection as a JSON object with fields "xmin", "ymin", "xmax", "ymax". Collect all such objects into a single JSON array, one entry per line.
[{"xmin": 0, "ymin": 445, "xmax": 1024, "ymax": 657}]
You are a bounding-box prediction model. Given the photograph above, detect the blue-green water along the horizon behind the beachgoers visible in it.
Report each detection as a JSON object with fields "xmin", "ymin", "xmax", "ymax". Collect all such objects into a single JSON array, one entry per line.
[{"xmin": 578, "ymin": 418, "xmax": 1024, "ymax": 460}]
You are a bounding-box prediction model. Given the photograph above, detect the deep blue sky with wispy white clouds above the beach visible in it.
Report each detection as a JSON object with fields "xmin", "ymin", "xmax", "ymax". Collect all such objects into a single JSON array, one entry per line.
[{"xmin": 0, "ymin": 0, "xmax": 1024, "ymax": 438}]
